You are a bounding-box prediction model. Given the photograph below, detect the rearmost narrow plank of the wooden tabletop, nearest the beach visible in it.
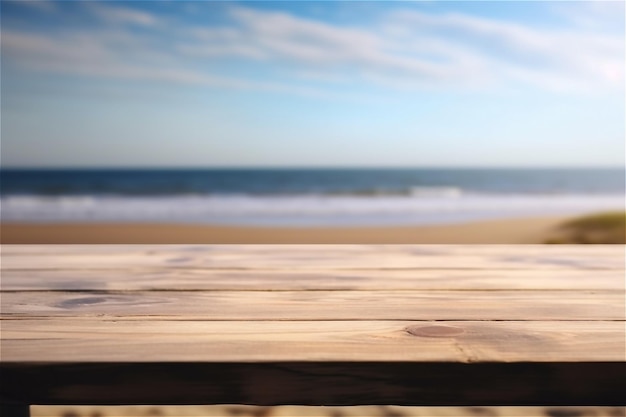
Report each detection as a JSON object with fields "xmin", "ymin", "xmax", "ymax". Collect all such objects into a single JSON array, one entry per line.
[{"xmin": 2, "ymin": 245, "xmax": 624, "ymax": 270}]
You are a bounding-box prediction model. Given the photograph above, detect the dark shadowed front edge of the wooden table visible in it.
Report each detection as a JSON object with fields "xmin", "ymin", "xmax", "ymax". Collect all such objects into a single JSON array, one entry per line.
[{"xmin": 0, "ymin": 362, "xmax": 626, "ymax": 406}]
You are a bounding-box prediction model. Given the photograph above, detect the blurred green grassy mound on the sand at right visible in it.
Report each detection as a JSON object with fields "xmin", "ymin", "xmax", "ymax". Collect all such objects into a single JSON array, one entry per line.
[{"xmin": 545, "ymin": 212, "xmax": 626, "ymax": 244}]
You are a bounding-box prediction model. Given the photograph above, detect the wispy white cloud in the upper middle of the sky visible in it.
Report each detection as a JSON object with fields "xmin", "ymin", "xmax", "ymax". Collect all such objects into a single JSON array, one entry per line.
[{"xmin": 181, "ymin": 7, "xmax": 472, "ymax": 82}]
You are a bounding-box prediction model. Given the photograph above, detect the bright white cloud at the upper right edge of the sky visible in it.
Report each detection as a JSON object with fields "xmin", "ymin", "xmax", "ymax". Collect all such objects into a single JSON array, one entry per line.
[{"xmin": 382, "ymin": 11, "xmax": 624, "ymax": 90}]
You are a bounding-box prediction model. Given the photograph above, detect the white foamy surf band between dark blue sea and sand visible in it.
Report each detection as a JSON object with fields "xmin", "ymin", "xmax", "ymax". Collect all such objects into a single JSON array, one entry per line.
[{"xmin": 0, "ymin": 191, "xmax": 625, "ymax": 226}]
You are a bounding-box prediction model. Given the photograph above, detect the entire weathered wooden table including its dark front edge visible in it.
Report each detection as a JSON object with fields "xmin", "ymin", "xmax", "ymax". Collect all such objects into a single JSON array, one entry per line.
[{"xmin": 0, "ymin": 245, "xmax": 626, "ymax": 405}]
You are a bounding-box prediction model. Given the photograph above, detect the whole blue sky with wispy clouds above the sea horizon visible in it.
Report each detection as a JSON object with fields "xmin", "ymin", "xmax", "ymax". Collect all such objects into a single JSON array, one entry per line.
[{"xmin": 0, "ymin": 0, "xmax": 626, "ymax": 167}]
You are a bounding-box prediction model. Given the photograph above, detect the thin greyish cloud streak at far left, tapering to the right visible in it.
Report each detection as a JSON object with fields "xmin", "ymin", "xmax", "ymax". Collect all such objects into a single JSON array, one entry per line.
[{"xmin": 1, "ymin": 30, "xmax": 346, "ymax": 98}]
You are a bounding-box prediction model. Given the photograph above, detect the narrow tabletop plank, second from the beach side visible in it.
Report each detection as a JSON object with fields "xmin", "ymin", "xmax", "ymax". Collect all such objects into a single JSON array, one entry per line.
[{"xmin": 1, "ymin": 266, "xmax": 626, "ymax": 292}]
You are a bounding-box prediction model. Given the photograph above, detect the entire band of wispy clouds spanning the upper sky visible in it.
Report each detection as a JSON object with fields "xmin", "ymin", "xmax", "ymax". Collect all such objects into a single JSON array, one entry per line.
[{"xmin": 2, "ymin": 3, "xmax": 624, "ymax": 96}]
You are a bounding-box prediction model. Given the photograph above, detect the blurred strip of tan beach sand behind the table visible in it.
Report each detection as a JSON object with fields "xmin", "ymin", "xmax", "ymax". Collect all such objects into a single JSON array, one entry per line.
[{"xmin": 0, "ymin": 217, "xmax": 568, "ymax": 244}]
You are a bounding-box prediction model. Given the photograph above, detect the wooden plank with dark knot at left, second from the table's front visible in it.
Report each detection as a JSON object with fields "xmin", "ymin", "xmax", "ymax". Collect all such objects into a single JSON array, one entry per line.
[{"xmin": 0, "ymin": 290, "xmax": 626, "ymax": 321}]
